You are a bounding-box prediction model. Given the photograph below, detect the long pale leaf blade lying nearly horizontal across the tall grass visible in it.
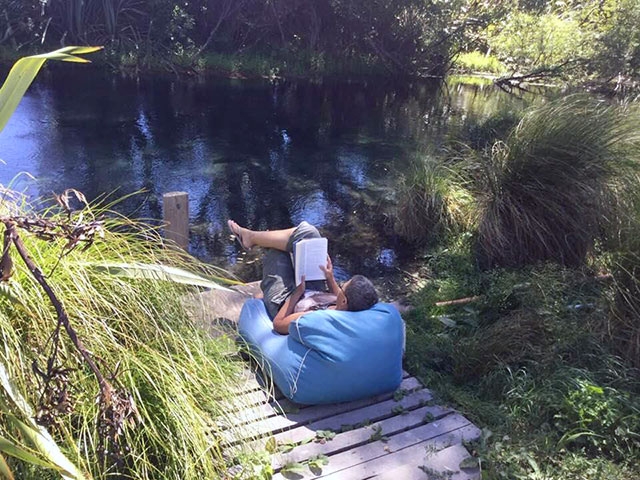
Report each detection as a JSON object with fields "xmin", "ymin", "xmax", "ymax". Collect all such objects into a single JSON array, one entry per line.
[{"xmin": 87, "ymin": 262, "xmax": 233, "ymax": 292}]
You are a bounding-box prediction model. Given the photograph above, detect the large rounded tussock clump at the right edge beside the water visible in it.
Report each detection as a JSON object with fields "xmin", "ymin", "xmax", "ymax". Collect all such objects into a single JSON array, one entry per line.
[{"xmin": 474, "ymin": 96, "xmax": 640, "ymax": 267}]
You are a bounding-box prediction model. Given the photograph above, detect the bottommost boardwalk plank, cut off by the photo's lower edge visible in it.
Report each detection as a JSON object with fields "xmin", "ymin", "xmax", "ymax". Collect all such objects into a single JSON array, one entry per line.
[{"xmin": 364, "ymin": 444, "xmax": 481, "ymax": 480}]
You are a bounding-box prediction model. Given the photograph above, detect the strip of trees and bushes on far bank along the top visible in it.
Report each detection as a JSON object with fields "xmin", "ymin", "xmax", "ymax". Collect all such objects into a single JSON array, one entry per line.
[{"xmin": 0, "ymin": 0, "xmax": 640, "ymax": 81}]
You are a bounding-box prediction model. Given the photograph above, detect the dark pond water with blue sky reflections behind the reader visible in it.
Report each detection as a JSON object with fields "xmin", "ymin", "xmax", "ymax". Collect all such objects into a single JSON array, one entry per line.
[{"xmin": 0, "ymin": 69, "xmax": 523, "ymax": 282}]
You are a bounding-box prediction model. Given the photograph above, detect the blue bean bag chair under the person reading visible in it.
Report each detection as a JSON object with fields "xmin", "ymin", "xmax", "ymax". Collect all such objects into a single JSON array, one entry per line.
[{"xmin": 239, "ymin": 299, "xmax": 404, "ymax": 405}]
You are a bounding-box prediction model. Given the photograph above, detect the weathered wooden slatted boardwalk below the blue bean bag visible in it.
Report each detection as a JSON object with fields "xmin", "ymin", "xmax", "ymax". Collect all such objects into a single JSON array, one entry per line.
[{"xmin": 226, "ymin": 374, "xmax": 480, "ymax": 480}]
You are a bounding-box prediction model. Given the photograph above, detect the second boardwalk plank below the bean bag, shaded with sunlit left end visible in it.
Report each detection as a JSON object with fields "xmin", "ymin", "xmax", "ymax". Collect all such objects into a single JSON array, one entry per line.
[{"xmin": 225, "ymin": 378, "xmax": 433, "ymax": 442}]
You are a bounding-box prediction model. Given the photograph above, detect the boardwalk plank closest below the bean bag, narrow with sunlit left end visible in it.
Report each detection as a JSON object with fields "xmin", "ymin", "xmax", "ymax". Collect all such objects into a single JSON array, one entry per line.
[{"xmin": 231, "ymin": 378, "xmax": 421, "ymax": 430}]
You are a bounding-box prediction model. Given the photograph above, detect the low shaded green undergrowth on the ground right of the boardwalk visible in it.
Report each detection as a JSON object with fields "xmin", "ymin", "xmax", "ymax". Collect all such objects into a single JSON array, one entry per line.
[{"xmin": 405, "ymin": 231, "xmax": 640, "ymax": 480}]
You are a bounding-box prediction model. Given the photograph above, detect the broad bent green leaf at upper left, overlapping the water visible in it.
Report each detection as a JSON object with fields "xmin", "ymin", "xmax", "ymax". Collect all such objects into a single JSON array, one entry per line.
[{"xmin": 0, "ymin": 47, "xmax": 102, "ymax": 131}]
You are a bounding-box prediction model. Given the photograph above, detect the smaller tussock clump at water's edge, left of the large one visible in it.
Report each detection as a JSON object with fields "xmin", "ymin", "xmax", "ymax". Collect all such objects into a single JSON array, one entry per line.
[{"xmin": 394, "ymin": 161, "xmax": 474, "ymax": 245}]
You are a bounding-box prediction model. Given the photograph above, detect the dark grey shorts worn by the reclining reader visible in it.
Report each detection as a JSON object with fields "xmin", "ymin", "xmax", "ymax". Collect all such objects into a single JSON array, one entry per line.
[{"xmin": 260, "ymin": 221, "xmax": 327, "ymax": 320}]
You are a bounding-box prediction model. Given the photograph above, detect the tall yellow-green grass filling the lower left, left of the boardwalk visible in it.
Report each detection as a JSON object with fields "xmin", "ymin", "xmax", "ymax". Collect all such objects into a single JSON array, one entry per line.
[{"xmin": 0, "ymin": 197, "xmax": 262, "ymax": 479}]
